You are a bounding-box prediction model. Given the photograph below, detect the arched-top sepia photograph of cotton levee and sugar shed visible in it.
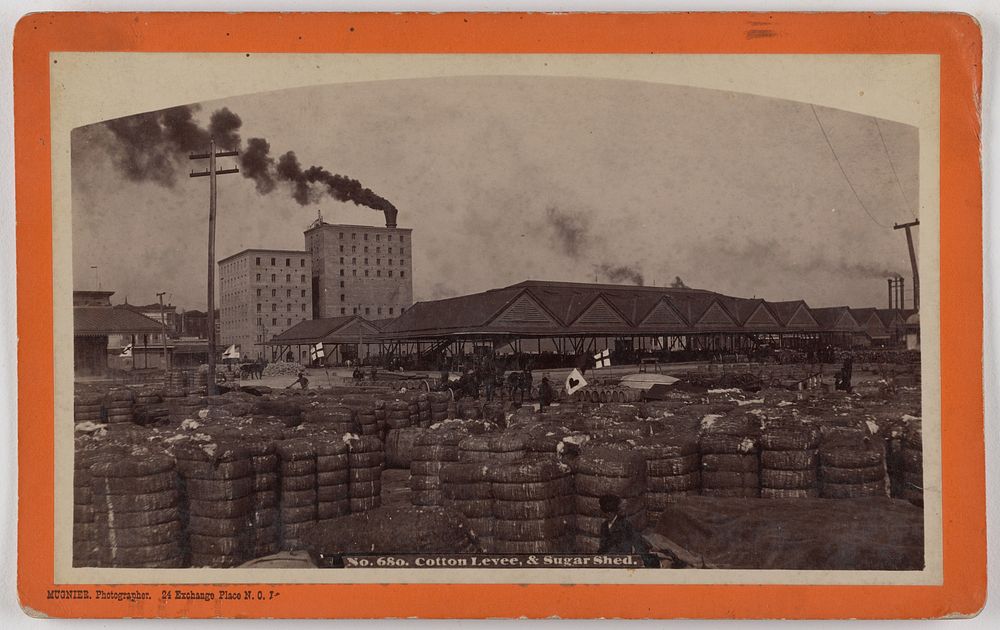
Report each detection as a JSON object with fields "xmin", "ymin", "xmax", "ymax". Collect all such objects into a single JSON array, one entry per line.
[{"xmin": 57, "ymin": 54, "xmax": 940, "ymax": 583}]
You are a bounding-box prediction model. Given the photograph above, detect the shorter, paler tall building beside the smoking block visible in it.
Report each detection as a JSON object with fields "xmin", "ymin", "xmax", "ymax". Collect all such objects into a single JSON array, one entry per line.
[{"xmin": 219, "ymin": 249, "xmax": 313, "ymax": 359}]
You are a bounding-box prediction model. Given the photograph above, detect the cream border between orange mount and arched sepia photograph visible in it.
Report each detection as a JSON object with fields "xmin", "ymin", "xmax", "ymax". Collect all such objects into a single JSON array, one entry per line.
[{"xmin": 50, "ymin": 52, "xmax": 943, "ymax": 584}]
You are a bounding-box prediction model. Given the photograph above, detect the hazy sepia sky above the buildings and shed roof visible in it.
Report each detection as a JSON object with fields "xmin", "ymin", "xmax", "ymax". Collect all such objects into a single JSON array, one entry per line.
[{"xmin": 72, "ymin": 77, "xmax": 918, "ymax": 309}]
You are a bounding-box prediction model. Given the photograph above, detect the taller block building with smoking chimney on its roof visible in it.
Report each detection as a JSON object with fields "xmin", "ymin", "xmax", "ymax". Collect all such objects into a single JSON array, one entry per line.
[{"xmin": 305, "ymin": 220, "xmax": 413, "ymax": 320}]
